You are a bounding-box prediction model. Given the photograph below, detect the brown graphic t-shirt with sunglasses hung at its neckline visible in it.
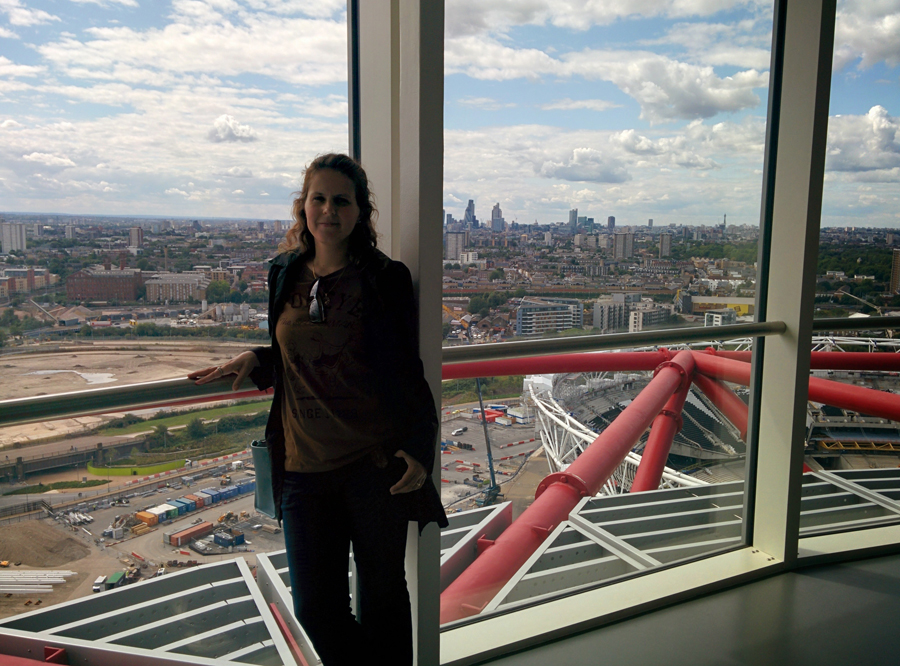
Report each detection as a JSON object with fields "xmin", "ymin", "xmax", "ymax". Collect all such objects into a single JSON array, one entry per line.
[{"xmin": 275, "ymin": 264, "xmax": 392, "ymax": 472}]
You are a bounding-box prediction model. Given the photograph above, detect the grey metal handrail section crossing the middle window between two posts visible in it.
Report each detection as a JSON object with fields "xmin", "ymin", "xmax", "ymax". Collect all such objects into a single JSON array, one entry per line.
[{"xmin": 443, "ymin": 321, "xmax": 787, "ymax": 364}]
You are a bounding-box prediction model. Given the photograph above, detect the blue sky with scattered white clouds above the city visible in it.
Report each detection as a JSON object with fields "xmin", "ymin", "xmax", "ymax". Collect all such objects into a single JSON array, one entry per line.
[{"xmin": 0, "ymin": 0, "xmax": 900, "ymax": 227}]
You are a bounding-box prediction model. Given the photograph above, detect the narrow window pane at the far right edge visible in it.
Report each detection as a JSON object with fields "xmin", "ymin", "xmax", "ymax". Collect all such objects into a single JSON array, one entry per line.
[{"xmin": 800, "ymin": 0, "xmax": 900, "ymax": 538}]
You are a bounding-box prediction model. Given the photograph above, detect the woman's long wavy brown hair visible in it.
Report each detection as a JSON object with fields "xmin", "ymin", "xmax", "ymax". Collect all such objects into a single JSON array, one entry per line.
[{"xmin": 278, "ymin": 153, "xmax": 378, "ymax": 261}]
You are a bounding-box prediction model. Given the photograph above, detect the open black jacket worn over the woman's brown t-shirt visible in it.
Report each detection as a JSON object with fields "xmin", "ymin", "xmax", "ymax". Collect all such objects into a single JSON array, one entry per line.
[{"xmin": 250, "ymin": 245, "xmax": 447, "ymax": 530}]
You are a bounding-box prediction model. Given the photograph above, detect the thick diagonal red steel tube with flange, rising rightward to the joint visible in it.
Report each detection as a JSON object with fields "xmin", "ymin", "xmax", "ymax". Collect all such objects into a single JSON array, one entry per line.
[{"xmin": 441, "ymin": 351, "xmax": 694, "ymax": 624}]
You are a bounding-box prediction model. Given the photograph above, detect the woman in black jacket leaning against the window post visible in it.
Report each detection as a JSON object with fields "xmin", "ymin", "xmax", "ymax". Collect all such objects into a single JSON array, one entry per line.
[{"xmin": 189, "ymin": 154, "xmax": 447, "ymax": 666}]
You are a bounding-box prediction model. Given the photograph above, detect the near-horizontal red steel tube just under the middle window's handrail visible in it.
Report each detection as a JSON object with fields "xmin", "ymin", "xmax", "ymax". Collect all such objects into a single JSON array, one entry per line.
[{"xmin": 441, "ymin": 349, "xmax": 672, "ymax": 379}]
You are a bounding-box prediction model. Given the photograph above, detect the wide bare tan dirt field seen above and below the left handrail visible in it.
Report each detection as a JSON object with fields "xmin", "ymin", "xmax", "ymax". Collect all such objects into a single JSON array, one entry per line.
[{"xmin": 0, "ymin": 340, "xmax": 254, "ymax": 450}]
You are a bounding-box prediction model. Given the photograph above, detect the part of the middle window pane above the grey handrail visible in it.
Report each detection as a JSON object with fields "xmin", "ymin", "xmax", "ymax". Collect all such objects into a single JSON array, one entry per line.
[{"xmin": 443, "ymin": 1, "xmax": 772, "ymax": 344}]
